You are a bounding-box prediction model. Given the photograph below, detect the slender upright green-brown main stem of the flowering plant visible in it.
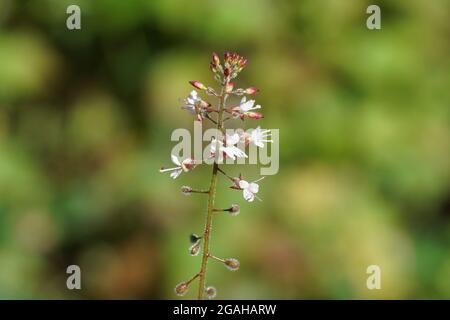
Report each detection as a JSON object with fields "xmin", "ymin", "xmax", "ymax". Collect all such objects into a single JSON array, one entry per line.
[{"xmin": 198, "ymin": 86, "xmax": 226, "ymax": 300}]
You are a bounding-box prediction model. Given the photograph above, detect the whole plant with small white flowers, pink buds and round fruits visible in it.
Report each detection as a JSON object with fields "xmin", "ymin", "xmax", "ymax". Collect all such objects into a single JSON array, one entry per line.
[{"xmin": 160, "ymin": 52, "xmax": 272, "ymax": 299}]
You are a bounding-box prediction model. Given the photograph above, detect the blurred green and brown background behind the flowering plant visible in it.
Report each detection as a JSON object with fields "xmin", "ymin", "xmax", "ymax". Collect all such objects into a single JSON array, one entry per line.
[{"xmin": 0, "ymin": 0, "xmax": 450, "ymax": 299}]
